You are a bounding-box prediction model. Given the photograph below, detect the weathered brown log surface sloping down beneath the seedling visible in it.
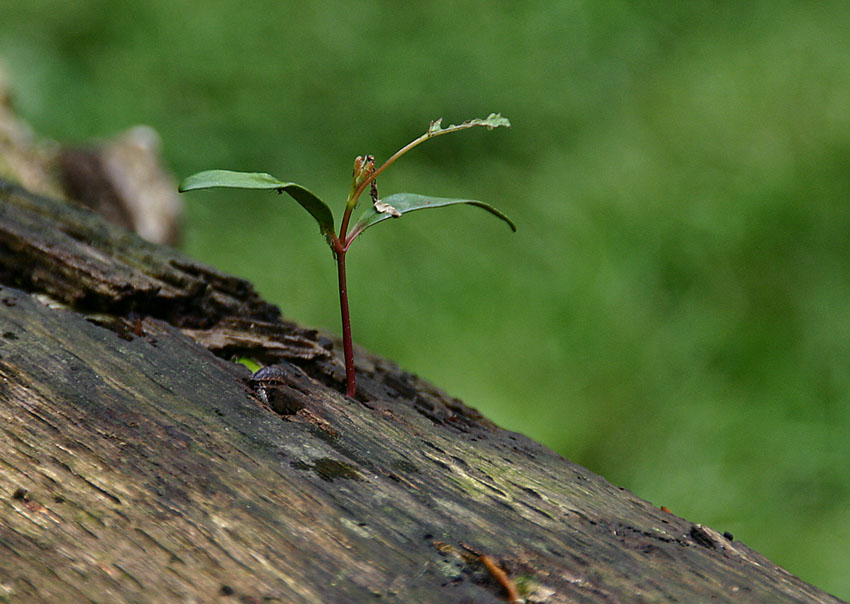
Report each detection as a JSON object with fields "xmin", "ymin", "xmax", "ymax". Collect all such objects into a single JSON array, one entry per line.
[{"xmin": 0, "ymin": 184, "xmax": 839, "ymax": 604}]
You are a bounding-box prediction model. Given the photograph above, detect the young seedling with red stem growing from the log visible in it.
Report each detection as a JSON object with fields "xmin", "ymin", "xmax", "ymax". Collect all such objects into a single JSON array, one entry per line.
[{"xmin": 178, "ymin": 113, "xmax": 516, "ymax": 396}]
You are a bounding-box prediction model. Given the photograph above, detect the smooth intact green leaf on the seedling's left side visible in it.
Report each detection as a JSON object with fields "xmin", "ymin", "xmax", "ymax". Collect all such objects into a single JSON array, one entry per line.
[{"xmin": 177, "ymin": 170, "xmax": 334, "ymax": 235}]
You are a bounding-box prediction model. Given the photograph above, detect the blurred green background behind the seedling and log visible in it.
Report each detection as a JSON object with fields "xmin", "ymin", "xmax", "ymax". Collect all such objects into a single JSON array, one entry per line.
[{"xmin": 0, "ymin": 0, "xmax": 850, "ymax": 598}]
